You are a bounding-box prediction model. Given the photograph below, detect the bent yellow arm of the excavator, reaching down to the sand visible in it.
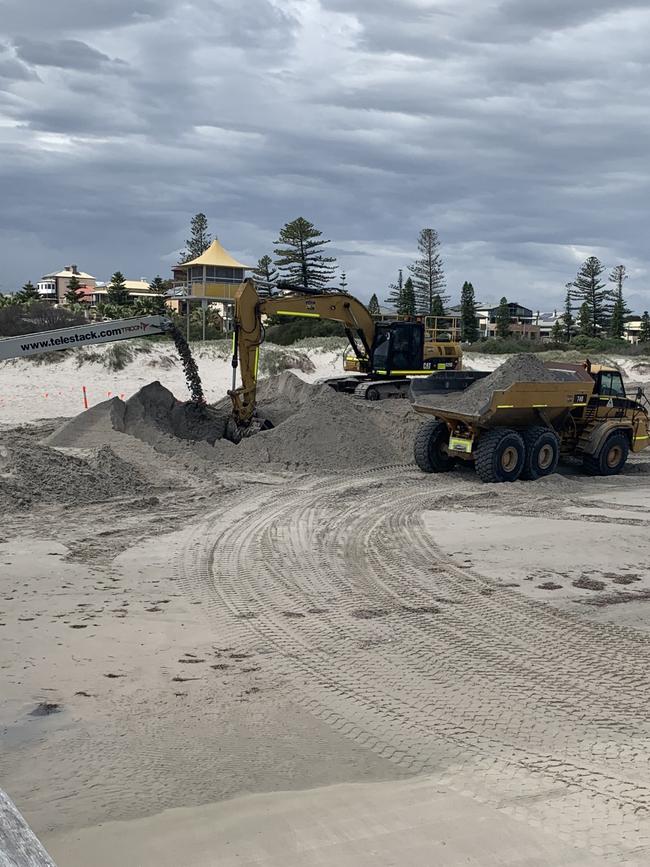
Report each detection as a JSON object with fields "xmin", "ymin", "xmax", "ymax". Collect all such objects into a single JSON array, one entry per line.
[{"xmin": 228, "ymin": 279, "xmax": 375, "ymax": 441}]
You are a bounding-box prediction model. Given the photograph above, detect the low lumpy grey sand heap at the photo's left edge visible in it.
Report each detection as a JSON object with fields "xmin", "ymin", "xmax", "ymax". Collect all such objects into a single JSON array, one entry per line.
[{"xmin": 0, "ymin": 438, "xmax": 146, "ymax": 510}]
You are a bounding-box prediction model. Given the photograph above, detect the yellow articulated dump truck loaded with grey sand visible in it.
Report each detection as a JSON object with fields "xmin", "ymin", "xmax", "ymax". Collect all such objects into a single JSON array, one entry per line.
[{"xmin": 411, "ymin": 361, "xmax": 650, "ymax": 482}]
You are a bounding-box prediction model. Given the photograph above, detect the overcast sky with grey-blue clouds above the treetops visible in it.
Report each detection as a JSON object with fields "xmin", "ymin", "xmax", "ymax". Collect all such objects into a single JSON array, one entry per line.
[{"xmin": 0, "ymin": 0, "xmax": 650, "ymax": 310}]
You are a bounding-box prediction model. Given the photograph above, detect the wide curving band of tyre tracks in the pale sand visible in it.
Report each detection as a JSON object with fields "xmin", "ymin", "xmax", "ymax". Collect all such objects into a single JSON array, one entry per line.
[{"xmin": 179, "ymin": 467, "xmax": 650, "ymax": 864}]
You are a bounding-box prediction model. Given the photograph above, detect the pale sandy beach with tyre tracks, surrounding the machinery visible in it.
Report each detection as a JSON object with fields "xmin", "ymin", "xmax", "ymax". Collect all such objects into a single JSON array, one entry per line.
[{"xmin": 0, "ymin": 353, "xmax": 650, "ymax": 867}]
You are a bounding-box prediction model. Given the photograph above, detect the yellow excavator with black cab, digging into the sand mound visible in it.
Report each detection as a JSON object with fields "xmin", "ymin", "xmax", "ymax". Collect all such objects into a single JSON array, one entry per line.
[{"xmin": 227, "ymin": 279, "xmax": 462, "ymax": 442}]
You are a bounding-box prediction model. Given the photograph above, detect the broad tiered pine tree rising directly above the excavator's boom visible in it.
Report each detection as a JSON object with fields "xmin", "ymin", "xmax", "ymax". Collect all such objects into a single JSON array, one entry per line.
[{"xmin": 274, "ymin": 217, "xmax": 336, "ymax": 292}]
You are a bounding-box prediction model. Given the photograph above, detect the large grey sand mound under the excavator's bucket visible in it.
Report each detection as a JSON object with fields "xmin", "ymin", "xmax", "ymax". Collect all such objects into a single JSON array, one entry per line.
[{"xmin": 46, "ymin": 371, "xmax": 420, "ymax": 472}]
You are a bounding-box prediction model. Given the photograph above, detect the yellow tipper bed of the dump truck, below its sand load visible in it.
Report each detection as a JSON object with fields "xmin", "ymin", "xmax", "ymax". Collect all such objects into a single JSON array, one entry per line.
[{"xmin": 414, "ymin": 376, "xmax": 594, "ymax": 428}]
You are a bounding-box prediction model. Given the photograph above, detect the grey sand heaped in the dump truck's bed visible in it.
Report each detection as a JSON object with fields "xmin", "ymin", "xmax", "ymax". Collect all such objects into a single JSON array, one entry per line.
[{"xmin": 418, "ymin": 353, "xmax": 560, "ymax": 415}]
